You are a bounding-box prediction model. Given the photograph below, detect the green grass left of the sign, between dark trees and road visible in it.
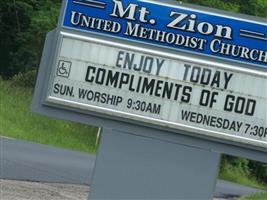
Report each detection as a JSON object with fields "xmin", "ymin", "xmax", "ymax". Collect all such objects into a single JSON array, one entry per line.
[{"xmin": 0, "ymin": 80, "xmax": 97, "ymax": 153}]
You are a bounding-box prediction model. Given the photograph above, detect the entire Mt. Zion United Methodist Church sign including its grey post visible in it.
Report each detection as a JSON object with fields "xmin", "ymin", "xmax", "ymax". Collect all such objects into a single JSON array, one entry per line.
[{"xmin": 33, "ymin": 0, "xmax": 267, "ymax": 199}]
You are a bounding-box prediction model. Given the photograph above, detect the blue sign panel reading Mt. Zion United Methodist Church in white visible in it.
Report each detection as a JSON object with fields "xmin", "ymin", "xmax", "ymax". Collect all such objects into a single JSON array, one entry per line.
[{"xmin": 63, "ymin": 0, "xmax": 267, "ymax": 69}]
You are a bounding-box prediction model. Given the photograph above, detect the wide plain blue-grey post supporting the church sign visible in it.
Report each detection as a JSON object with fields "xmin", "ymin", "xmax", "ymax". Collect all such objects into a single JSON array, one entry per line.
[{"xmin": 89, "ymin": 129, "xmax": 220, "ymax": 200}]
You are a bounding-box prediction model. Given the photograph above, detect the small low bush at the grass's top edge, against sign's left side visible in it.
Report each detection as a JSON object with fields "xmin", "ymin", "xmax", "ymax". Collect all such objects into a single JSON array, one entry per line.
[{"xmin": 12, "ymin": 69, "xmax": 37, "ymax": 88}]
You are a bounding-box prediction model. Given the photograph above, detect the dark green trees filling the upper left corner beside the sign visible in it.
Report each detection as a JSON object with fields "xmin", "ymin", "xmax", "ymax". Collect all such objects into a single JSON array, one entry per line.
[{"xmin": 0, "ymin": 0, "xmax": 61, "ymax": 78}]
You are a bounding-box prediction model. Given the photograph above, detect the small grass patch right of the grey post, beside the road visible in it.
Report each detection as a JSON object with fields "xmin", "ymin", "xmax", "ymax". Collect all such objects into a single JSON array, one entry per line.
[{"xmin": 219, "ymin": 160, "xmax": 267, "ymax": 190}]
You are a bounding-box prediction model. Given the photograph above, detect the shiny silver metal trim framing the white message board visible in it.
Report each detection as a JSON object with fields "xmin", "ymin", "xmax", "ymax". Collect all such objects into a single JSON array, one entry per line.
[{"xmin": 45, "ymin": 31, "xmax": 267, "ymax": 150}]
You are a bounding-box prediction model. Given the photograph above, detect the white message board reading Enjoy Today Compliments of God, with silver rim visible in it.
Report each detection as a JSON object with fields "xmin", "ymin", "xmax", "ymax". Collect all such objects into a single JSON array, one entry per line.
[{"xmin": 46, "ymin": 34, "xmax": 267, "ymax": 148}]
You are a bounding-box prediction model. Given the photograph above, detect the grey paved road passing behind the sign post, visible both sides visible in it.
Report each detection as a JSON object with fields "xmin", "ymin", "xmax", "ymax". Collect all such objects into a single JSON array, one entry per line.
[{"xmin": 0, "ymin": 137, "xmax": 264, "ymax": 197}]
